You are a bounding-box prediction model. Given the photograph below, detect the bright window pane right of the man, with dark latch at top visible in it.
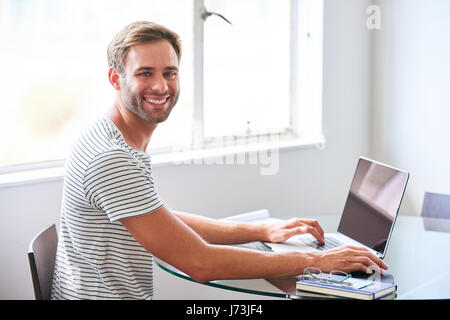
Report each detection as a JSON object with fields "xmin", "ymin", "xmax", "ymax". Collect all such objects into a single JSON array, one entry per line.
[{"xmin": 203, "ymin": 0, "xmax": 290, "ymax": 137}]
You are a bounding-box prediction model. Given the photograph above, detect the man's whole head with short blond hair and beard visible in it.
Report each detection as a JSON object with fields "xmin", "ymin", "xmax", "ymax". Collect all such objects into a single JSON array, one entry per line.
[{"xmin": 108, "ymin": 21, "xmax": 181, "ymax": 123}]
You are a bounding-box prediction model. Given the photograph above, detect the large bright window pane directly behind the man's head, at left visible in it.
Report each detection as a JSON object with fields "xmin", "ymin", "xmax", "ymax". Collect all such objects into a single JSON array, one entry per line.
[{"xmin": 0, "ymin": 0, "xmax": 193, "ymax": 166}]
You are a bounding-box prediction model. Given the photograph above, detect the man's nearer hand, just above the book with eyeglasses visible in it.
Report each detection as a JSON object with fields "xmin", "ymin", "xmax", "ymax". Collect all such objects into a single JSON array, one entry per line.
[{"xmin": 312, "ymin": 246, "xmax": 388, "ymax": 273}]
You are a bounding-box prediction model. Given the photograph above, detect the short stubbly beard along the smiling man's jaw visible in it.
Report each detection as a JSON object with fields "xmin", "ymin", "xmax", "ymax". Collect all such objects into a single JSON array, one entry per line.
[{"xmin": 120, "ymin": 77, "xmax": 180, "ymax": 123}]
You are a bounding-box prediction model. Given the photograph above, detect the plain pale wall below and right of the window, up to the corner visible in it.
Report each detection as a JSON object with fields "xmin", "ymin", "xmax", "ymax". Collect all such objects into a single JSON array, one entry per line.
[{"xmin": 0, "ymin": 0, "xmax": 371, "ymax": 299}]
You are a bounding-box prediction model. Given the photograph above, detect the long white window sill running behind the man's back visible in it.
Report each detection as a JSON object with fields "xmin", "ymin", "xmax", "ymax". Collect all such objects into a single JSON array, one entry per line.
[{"xmin": 0, "ymin": 136, "xmax": 325, "ymax": 188}]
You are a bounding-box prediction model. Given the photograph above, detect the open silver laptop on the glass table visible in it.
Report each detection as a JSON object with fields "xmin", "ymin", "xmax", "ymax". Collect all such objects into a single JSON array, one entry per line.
[{"xmin": 268, "ymin": 157, "xmax": 409, "ymax": 259}]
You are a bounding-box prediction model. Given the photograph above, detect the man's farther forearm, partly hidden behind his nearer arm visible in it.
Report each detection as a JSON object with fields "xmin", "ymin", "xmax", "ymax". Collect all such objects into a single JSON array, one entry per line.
[{"xmin": 171, "ymin": 210, "xmax": 267, "ymax": 244}]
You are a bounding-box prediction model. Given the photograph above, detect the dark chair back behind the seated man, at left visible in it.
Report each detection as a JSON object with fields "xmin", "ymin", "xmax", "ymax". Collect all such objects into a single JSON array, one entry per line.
[{"xmin": 28, "ymin": 224, "xmax": 58, "ymax": 300}]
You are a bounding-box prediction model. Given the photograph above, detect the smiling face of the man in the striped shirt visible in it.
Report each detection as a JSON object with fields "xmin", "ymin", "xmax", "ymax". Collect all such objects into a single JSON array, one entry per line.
[{"xmin": 120, "ymin": 40, "xmax": 180, "ymax": 123}]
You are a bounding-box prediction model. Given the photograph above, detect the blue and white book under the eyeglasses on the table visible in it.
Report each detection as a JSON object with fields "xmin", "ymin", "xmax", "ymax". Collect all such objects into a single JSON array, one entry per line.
[{"xmin": 296, "ymin": 275, "xmax": 397, "ymax": 300}]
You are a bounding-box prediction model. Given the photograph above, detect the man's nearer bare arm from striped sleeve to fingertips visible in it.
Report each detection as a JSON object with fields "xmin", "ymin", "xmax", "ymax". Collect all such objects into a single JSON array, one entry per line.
[{"xmin": 121, "ymin": 206, "xmax": 382, "ymax": 282}]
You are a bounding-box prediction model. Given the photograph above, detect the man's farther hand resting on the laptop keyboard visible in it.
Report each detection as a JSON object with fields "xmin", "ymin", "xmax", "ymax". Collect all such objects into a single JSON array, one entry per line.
[{"xmin": 263, "ymin": 218, "xmax": 325, "ymax": 243}]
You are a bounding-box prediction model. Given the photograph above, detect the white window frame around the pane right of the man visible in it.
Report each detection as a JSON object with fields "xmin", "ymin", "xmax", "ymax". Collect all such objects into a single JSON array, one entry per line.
[{"xmin": 149, "ymin": 0, "xmax": 325, "ymax": 159}]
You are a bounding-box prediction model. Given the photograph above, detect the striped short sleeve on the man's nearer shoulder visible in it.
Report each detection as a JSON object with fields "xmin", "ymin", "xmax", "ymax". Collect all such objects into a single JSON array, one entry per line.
[{"xmin": 83, "ymin": 150, "xmax": 163, "ymax": 222}]
